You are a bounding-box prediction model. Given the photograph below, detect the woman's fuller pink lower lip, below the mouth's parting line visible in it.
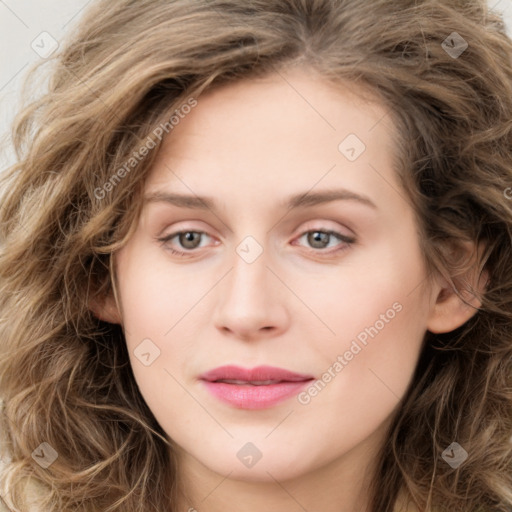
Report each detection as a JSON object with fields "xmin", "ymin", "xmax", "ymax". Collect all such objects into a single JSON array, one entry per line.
[{"xmin": 203, "ymin": 379, "xmax": 312, "ymax": 409}]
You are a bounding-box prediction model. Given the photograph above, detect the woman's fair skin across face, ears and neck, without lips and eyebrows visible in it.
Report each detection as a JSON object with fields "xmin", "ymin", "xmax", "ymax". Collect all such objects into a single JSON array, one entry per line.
[{"xmin": 93, "ymin": 69, "xmax": 484, "ymax": 512}]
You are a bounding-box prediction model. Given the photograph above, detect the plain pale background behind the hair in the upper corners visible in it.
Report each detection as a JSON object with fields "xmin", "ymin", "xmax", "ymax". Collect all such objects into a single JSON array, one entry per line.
[{"xmin": 0, "ymin": 0, "xmax": 512, "ymax": 170}]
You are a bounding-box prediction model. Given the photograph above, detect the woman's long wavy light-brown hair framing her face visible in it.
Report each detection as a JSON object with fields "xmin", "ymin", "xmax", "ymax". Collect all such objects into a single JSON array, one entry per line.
[{"xmin": 0, "ymin": 0, "xmax": 512, "ymax": 512}]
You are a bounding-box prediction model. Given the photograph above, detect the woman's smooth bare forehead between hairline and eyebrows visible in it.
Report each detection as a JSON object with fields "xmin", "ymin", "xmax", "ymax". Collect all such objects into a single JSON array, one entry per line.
[{"xmin": 146, "ymin": 70, "xmax": 395, "ymax": 210}]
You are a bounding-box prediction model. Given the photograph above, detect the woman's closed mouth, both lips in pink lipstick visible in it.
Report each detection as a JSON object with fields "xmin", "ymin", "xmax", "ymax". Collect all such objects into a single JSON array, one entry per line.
[{"xmin": 200, "ymin": 365, "xmax": 314, "ymax": 409}]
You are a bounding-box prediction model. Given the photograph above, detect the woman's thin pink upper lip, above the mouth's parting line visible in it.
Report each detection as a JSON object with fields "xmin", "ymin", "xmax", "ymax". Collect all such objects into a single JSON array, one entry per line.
[{"xmin": 200, "ymin": 365, "xmax": 314, "ymax": 382}]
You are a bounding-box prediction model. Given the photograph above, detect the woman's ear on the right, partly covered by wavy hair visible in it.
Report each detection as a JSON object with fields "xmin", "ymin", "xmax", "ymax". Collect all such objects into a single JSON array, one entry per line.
[{"xmin": 427, "ymin": 243, "xmax": 489, "ymax": 333}]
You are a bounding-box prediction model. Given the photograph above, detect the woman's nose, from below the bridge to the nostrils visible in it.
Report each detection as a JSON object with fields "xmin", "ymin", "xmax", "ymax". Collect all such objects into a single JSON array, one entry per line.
[{"xmin": 213, "ymin": 242, "xmax": 290, "ymax": 341}]
